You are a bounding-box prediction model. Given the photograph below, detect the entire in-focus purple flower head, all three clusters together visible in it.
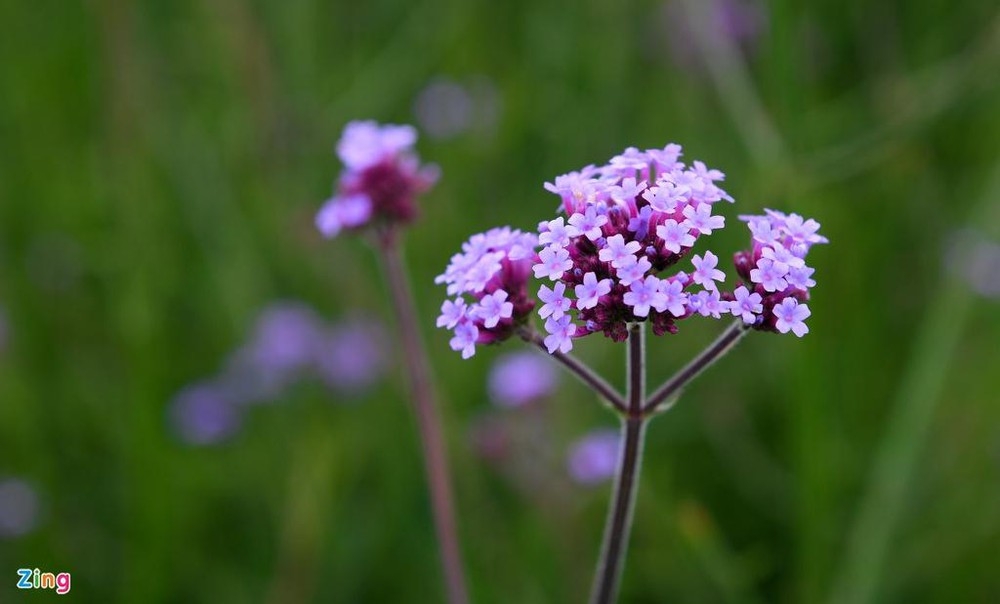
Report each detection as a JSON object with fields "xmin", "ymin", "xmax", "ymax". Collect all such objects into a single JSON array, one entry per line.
[{"xmin": 438, "ymin": 144, "xmax": 826, "ymax": 358}]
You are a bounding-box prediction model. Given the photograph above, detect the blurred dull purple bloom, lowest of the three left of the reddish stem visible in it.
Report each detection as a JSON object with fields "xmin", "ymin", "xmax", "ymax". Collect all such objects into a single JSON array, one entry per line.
[{"xmin": 170, "ymin": 382, "xmax": 242, "ymax": 445}]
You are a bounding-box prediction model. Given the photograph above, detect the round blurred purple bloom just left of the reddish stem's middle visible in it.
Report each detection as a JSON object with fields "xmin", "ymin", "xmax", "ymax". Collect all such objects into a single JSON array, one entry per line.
[{"xmin": 315, "ymin": 319, "xmax": 388, "ymax": 394}]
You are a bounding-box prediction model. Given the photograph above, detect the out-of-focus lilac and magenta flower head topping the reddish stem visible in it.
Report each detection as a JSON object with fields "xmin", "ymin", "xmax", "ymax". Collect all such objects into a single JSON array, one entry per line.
[{"xmin": 316, "ymin": 121, "xmax": 437, "ymax": 237}]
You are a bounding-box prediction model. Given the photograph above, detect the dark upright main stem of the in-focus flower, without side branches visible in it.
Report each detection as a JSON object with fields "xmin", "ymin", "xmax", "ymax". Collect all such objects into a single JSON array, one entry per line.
[{"xmin": 590, "ymin": 323, "xmax": 646, "ymax": 604}]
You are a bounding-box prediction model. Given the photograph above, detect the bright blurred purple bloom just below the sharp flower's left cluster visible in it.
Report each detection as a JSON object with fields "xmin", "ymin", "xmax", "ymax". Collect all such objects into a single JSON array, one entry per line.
[{"xmin": 489, "ymin": 351, "xmax": 557, "ymax": 407}]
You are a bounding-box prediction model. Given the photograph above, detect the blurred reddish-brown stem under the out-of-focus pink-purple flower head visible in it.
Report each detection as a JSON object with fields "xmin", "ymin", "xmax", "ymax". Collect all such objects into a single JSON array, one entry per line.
[{"xmin": 375, "ymin": 233, "xmax": 469, "ymax": 604}]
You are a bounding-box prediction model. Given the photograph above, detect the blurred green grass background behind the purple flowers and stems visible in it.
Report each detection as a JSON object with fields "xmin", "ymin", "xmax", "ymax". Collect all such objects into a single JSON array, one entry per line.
[{"xmin": 0, "ymin": 0, "xmax": 1000, "ymax": 603}]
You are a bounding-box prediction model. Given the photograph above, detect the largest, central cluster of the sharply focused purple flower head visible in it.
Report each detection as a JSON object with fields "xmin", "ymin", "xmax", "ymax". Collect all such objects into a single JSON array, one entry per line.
[{"xmin": 533, "ymin": 144, "xmax": 733, "ymax": 352}]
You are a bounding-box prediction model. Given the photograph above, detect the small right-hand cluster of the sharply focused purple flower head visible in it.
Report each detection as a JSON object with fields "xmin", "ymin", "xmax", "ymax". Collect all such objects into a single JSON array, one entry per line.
[{"xmin": 730, "ymin": 210, "xmax": 827, "ymax": 337}]
